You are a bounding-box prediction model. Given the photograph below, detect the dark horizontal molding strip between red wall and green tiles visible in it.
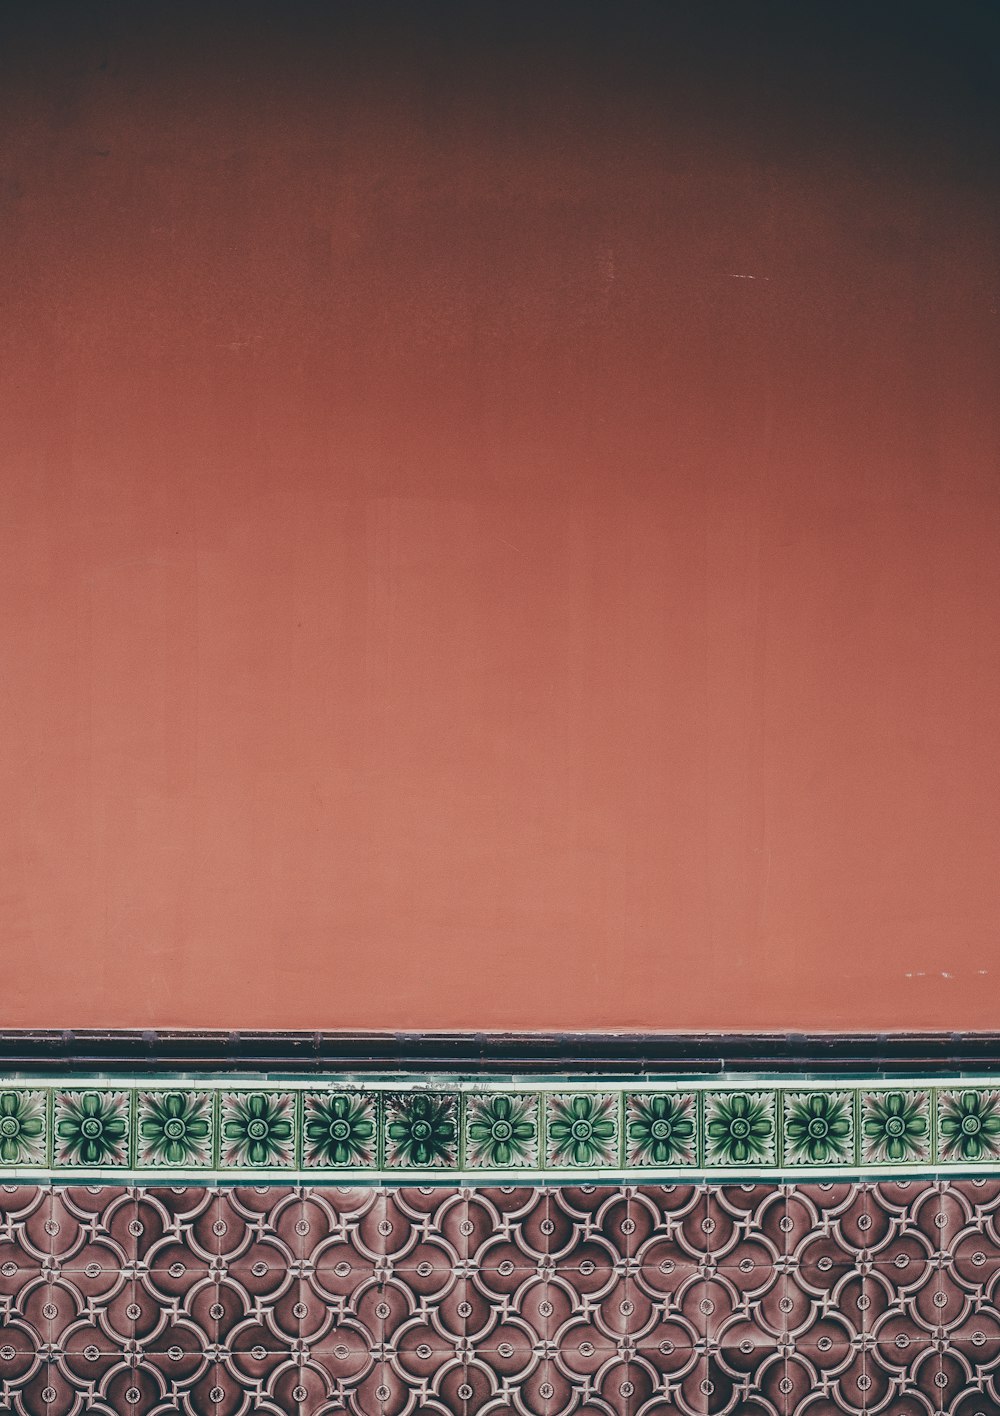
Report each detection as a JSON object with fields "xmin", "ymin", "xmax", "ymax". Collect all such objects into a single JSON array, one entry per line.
[{"xmin": 0, "ymin": 1029, "xmax": 1000, "ymax": 1076}]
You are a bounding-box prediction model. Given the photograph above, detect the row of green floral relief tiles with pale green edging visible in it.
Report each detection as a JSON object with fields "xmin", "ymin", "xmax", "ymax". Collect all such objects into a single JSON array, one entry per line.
[{"xmin": 0, "ymin": 1076, "xmax": 1000, "ymax": 1182}]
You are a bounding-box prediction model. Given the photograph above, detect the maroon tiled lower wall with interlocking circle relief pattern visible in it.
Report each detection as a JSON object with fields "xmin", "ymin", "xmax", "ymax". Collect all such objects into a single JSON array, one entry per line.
[{"xmin": 0, "ymin": 1181, "xmax": 1000, "ymax": 1416}]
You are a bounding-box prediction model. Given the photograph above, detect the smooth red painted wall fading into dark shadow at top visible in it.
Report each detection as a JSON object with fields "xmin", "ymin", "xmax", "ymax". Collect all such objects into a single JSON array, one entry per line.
[{"xmin": 0, "ymin": 3, "xmax": 1000, "ymax": 1029}]
